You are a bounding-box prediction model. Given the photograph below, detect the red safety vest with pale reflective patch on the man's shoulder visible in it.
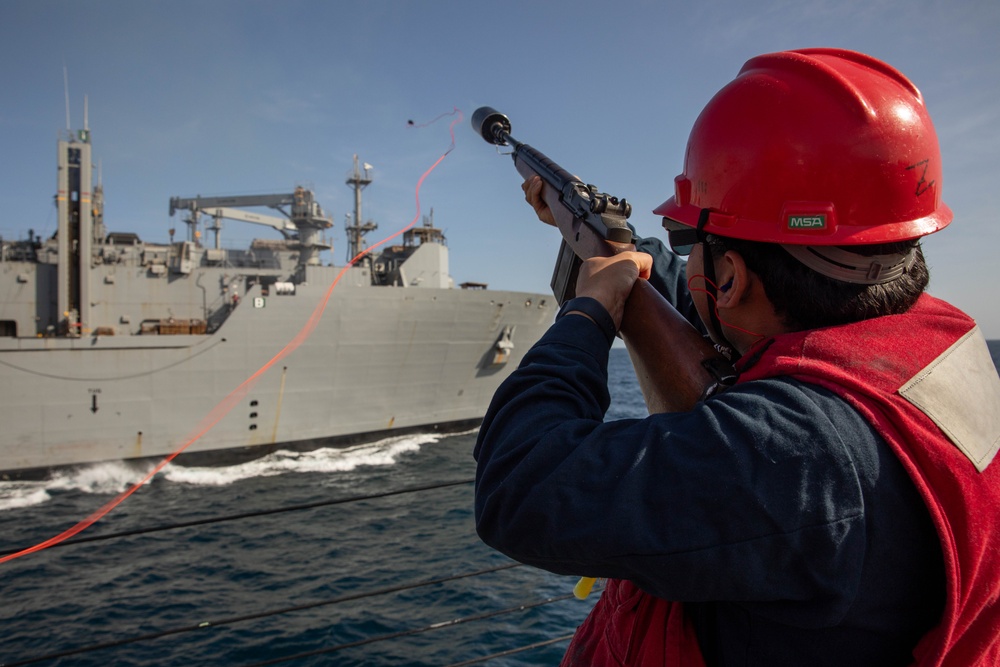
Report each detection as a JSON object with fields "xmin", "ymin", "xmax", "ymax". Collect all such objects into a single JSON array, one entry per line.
[{"xmin": 562, "ymin": 295, "xmax": 1000, "ymax": 667}]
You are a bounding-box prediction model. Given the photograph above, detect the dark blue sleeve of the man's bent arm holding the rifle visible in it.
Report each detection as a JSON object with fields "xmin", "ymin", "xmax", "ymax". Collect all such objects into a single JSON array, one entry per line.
[{"xmin": 475, "ymin": 315, "xmax": 865, "ymax": 615}]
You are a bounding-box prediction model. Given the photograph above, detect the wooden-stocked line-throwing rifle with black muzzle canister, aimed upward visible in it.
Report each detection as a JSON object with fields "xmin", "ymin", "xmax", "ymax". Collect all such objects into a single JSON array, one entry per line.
[{"xmin": 472, "ymin": 107, "xmax": 735, "ymax": 414}]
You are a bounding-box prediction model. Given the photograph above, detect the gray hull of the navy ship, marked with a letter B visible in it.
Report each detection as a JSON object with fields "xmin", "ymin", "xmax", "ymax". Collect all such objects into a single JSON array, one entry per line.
[{"xmin": 0, "ymin": 274, "xmax": 555, "ymax": 478}]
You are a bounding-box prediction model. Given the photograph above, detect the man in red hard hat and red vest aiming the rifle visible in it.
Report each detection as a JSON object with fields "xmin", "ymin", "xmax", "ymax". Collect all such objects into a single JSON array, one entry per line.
[{"xmin": 475, "ymin": 49, "xmax": 1000, "ymax": 667}]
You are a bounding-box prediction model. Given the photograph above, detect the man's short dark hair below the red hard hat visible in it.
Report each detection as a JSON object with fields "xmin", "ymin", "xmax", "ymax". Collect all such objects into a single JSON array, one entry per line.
[{"xmin": 708, "ymin": 235, "xmax": 930, "ymax": 331}]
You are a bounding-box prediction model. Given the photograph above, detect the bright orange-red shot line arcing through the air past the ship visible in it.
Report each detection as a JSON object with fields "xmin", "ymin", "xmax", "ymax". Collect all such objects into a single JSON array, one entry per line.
[{"xmin": 0, "ymin": 107, "xmax": 463, "ymax": 564}]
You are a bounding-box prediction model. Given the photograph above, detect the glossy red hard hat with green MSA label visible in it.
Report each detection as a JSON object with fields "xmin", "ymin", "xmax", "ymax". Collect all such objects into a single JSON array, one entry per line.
[{"xmin": 653, "ymin": 49, "xmax": 952, "ymax": 245}]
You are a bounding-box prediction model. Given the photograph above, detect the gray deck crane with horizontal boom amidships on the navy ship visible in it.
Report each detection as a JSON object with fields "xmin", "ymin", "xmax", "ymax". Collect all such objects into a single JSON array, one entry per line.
[{"xmin": 170, "ymin": 187, "xmax": 333, "ymax": 267}]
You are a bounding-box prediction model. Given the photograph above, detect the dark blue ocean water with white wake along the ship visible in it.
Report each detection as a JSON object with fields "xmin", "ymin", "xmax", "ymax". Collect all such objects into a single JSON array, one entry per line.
[{"xmin": 0, "ymin": 341, "xmax": 1000, "ymax": 667}]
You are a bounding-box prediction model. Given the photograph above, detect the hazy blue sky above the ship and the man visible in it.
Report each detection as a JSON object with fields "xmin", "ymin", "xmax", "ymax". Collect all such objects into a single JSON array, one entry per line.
[{"xmin": 0, "ymin": 0, "xmax": 1000, "ymax": 338}]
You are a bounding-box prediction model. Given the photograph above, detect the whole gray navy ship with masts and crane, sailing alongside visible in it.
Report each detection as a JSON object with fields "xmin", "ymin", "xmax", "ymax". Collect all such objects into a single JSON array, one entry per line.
[{"xmin": 0, "ymin": 125, "xmax": 556, "ymax": 479}]
